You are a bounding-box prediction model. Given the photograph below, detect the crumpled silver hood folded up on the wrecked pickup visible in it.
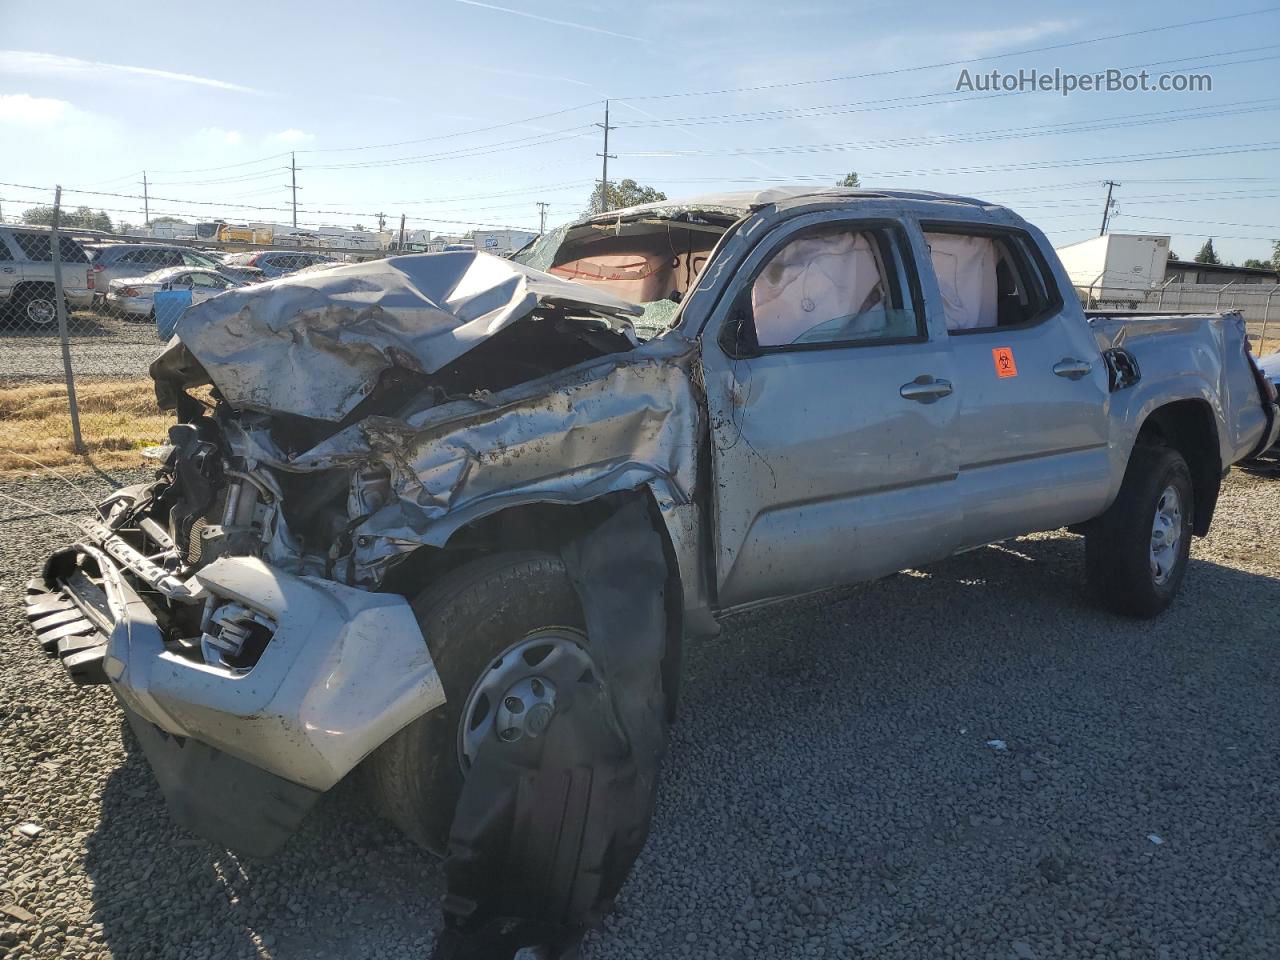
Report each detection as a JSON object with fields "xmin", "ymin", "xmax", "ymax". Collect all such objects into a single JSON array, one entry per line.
[{"xmin": 177, "ymin": 252, "xmax": 640, "ymax": 421}]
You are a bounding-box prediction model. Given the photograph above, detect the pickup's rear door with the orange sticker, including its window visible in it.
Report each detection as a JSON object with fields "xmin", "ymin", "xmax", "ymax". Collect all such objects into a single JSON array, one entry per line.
[{"xmin": 923, "ymin": 221, "xmax": 1111, "ymax": 547}]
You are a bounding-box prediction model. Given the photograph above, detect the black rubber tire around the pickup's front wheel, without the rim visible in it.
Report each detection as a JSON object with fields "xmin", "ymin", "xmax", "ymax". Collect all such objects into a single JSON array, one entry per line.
[{"xmin": 370, "ymin": 550, "xmax": 588, "ymax": 856}]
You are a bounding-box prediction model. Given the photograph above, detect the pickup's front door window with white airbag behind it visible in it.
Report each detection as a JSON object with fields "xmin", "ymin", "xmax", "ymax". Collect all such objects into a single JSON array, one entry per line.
[{"xmin": 750, "ymin": 224, "xmax": 922, "ymax": 347}]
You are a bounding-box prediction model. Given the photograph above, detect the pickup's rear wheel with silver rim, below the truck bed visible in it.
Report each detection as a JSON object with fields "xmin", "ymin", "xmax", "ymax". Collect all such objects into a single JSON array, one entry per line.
[{"xmin": 1084, "ymin": 445, "xmax": 1196, "ymax": 618}]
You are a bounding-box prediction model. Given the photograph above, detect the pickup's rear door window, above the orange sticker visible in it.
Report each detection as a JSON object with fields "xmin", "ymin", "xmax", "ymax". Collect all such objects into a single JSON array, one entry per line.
[{"xmin": 924, "ymin": 227, "xmax": 1060, "ymax": 334}]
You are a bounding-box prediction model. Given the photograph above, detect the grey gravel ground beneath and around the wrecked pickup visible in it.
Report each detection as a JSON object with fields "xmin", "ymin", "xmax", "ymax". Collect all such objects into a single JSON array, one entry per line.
[{"xmin": 0, "ymin": 472, "xmax": 1280, "ymax": 960}]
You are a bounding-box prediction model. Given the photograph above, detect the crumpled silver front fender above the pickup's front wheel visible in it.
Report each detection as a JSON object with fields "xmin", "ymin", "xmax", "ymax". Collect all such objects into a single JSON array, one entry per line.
[{"xmin": 335, "ymin": 340, "xmax": 701, "ymax": 585}]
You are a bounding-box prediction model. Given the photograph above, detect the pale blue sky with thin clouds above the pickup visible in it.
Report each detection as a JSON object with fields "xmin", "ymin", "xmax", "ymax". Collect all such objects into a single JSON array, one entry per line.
[{"xmin": 0, "ymin": 0, "xmax": 1280, "ymax": 261}]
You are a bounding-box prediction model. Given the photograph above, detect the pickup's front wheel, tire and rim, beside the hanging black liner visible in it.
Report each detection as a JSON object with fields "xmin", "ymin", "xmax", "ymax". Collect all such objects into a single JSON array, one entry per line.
[{"xmin": 370, "ymin": 550, "xmax": 594, "ymax": 856}]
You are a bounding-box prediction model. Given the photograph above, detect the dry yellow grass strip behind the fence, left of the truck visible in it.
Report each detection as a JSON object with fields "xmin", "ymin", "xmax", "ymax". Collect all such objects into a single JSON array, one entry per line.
[{"xmin": 0, "ymin": 378, "xmax": 174, "ymax": 472}]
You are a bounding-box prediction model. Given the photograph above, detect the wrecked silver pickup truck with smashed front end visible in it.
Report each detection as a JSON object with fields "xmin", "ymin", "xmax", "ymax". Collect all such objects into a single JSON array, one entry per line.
[{"xmin": 29, "ymin": 189, "xmax": 1277, "ymax": 931}]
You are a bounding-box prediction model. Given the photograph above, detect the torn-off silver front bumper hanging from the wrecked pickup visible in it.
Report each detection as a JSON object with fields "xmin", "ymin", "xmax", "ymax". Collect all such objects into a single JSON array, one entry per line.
[{"xmin": 27, "ymin": 538, "xmax": 444, "ymax": 855}]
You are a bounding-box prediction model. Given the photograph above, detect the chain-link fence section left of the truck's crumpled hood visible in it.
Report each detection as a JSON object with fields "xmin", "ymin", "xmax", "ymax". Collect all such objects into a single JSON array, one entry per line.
[{"xmin": 0, "ymin": 197, "xmax": 378, "ymax": 472}]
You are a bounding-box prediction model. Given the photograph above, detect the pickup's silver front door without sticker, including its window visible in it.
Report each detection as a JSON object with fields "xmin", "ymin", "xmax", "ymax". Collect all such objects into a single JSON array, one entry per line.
[{"xmin": 703, "ymin": 211, "xmax": 959, "ymax": 608}]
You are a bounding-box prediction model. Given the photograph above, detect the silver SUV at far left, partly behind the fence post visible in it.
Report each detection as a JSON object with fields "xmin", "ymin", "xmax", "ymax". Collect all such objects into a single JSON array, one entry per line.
[{"xmin": 0, "ymin": 225, "xmax": 93, "ymax": 328}]
